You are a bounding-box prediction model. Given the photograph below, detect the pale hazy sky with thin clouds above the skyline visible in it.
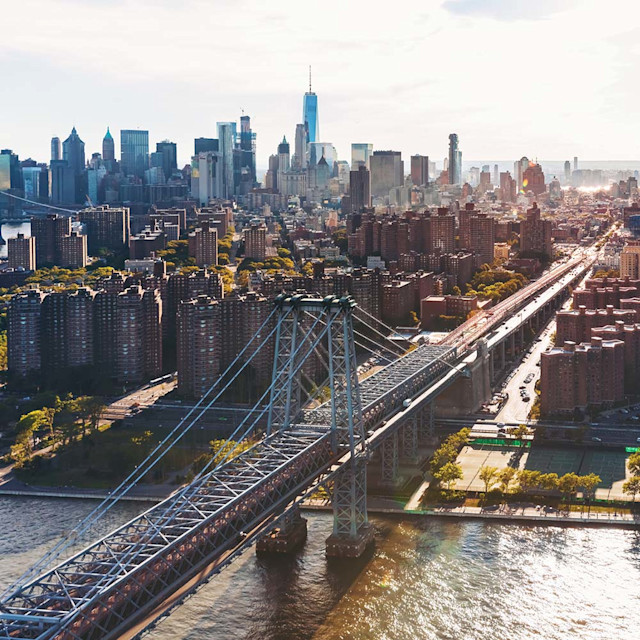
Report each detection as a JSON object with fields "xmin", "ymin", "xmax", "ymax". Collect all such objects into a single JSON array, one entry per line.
[{"xmin": 0, "ymin": 0, "xmax": 640, "ymax": 166}]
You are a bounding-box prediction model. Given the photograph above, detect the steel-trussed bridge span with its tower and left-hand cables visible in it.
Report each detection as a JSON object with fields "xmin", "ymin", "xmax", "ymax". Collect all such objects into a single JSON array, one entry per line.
[{"xmin": 0, "ymin": 295, "xmax": 464, "ymax": 640}]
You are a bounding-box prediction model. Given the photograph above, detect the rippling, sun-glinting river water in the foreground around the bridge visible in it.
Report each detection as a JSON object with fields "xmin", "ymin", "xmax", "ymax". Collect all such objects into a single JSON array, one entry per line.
[{"xmin": 0, "ymin": 498, "xmax": 640, "ymax": 640}]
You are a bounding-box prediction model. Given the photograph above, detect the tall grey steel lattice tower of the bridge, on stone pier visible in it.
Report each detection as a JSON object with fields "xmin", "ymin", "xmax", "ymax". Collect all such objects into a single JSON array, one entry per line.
[{"xmin": 267, "ymin": 295, "xmax": 373, "ymax": 557}]
